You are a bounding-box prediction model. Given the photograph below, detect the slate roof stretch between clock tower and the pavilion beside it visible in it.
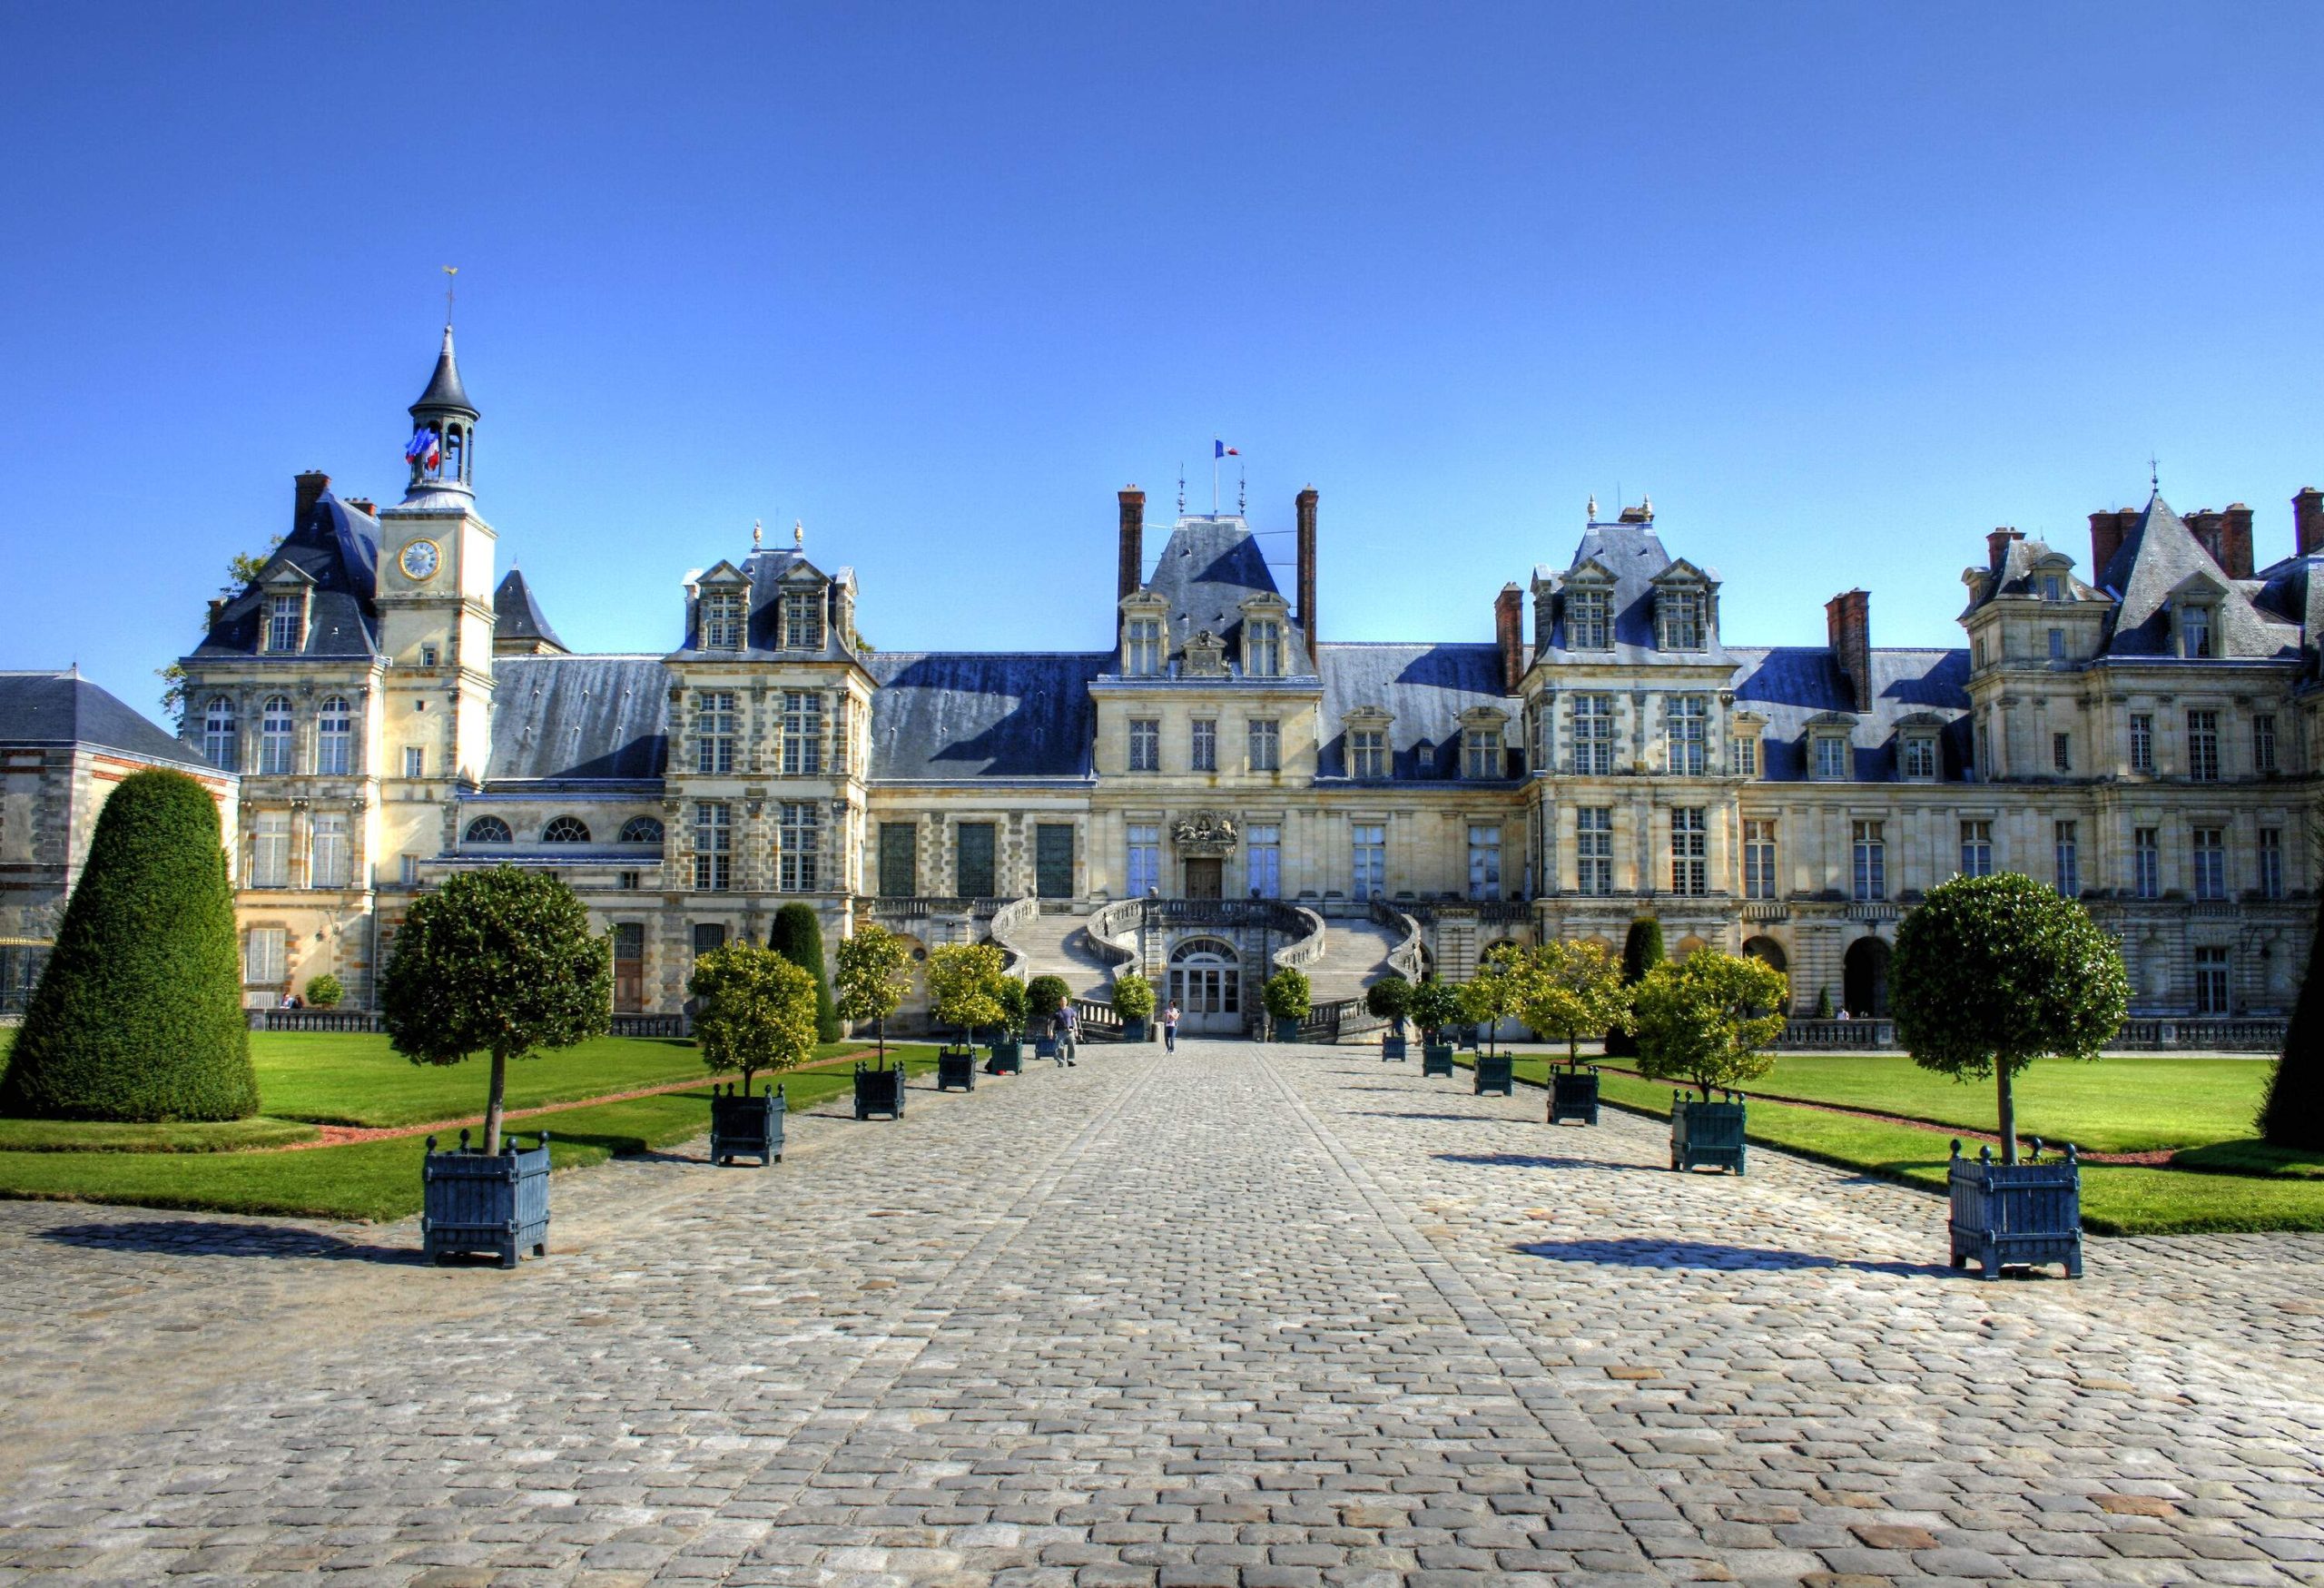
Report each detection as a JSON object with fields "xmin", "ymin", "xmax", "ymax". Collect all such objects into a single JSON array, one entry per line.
[{"xmin": 483, "ymin": 656, "xmax": 669, "ymax": 784}]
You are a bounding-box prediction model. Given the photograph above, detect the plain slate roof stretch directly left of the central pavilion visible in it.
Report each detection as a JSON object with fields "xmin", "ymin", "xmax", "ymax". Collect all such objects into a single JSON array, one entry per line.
[{"xmin": 867, "ymin": 651, "xmax": 1113, "ymax": 781}]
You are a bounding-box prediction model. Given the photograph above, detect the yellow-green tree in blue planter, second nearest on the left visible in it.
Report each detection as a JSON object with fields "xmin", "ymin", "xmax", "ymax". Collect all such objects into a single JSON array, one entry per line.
[{"xmin": 685, "ymin": 940, "xmax": 816, "ymax": 1169}]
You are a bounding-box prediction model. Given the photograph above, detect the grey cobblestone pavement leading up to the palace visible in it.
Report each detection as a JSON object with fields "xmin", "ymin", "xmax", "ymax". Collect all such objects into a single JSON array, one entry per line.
[{"xmin": 0, "ymin": 1041, "xmax": 2324, "ymax": 1588}]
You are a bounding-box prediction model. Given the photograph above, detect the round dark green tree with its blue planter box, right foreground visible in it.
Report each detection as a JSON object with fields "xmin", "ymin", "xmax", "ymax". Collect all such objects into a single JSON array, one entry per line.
[{"xmin": 1889, "ymin": 872, "xmax": 2132, "ymax": 1278}]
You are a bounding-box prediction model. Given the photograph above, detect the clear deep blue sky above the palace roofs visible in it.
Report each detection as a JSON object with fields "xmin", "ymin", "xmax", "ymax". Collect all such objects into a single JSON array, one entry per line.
[{"xmin": 0, "ymin": 5, "xmax": 2324, "ymax": 725}]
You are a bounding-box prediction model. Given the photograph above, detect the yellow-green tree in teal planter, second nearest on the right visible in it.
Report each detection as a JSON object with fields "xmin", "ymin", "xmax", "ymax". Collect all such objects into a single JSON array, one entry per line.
[{"xmin": 1631, "ymin": 949, "xmax": 1789, "ymax": 1174}]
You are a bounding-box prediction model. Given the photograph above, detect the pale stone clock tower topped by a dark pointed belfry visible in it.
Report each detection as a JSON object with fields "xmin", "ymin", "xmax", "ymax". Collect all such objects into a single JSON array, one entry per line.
[{"xmin": 379, "ymin": 326, "xmax": 495, "ymax": 886}]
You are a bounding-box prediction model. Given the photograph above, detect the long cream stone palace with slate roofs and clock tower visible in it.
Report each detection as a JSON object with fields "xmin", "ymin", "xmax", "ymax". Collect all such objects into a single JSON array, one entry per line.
[{"xmin": 183, "ymin": 330, "xmax": 2324, "ymax": 1031}]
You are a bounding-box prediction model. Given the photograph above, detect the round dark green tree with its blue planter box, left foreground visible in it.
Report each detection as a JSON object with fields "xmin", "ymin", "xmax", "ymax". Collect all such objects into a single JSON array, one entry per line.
[{"xmin": 379, "ymin": 865, "xmax": 614, "ymax": 1267}]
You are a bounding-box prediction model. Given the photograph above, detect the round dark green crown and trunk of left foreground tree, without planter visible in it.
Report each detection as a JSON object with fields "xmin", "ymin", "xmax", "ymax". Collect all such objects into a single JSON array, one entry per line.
[{"xmin": 379, "ymin": 865, "xmax": 614, "ymax": 1153}]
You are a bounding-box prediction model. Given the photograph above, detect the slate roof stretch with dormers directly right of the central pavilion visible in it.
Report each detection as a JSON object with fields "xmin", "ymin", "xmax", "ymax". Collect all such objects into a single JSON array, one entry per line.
[{"xmin": 1315, "ymin": 639, "xmax": 1520, "ymax": 779}]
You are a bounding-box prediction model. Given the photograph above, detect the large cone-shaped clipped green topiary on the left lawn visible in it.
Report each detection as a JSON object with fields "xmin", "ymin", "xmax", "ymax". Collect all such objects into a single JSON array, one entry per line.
[{"xmin": 0, "ymin": 770, "xmax": 258, "ymax": 1120}]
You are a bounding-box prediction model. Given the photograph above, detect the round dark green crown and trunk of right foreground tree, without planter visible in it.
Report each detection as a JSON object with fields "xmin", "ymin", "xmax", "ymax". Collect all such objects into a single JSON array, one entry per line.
[{"xmin": 1889, "ymin": 872, "xmax": 2132, "ymax": 1162}]
